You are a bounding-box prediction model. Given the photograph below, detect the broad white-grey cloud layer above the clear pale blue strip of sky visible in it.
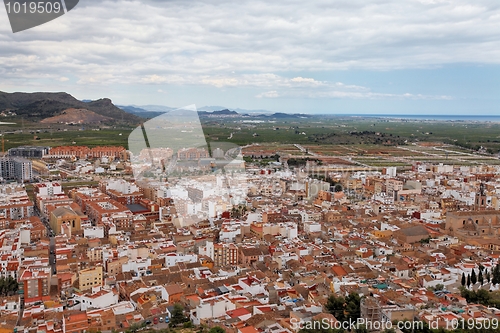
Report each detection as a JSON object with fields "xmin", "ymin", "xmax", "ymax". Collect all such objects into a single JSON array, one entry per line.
[{"xmin": 0, "ymin": 0, "xmax": 500, "ymax": 99}]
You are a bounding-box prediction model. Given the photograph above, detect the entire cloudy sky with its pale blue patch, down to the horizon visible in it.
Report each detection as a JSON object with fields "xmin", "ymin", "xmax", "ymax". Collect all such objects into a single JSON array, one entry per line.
[{"xmin": 0, "ymin": 0, "xmax": 500, "ymax": 115}]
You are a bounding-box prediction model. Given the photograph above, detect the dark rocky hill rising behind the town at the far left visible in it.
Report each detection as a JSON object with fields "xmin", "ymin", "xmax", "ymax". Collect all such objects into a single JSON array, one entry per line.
[{"xmin": 0, "ymin": 91, "xmax": 143, "ymax": 124}]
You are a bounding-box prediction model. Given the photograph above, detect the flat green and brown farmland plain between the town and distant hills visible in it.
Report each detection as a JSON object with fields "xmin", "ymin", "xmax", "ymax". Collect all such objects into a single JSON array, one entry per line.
[{"xmin": 0, "ymin": 116, "xmax": 500, "ymax": 167}]
